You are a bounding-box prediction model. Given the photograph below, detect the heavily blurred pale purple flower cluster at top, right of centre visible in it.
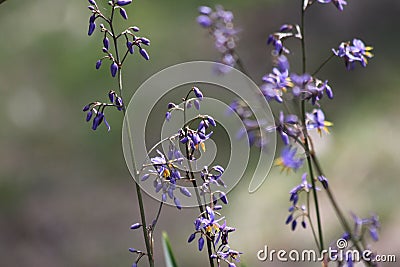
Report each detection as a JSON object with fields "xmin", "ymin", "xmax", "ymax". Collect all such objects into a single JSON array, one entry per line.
[{"xmin": 197, "ymin": 6, "xmax": 239, "ymax": 73}]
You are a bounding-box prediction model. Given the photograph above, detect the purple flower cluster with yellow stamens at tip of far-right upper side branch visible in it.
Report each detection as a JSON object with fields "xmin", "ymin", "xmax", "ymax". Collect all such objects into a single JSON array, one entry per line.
[{"xmin": 332, "ymin": 39, "xmax": 373, "ymax": 70}]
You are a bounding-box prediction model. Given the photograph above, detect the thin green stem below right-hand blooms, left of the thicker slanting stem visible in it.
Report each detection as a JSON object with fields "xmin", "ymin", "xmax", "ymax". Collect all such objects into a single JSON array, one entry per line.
[{"xmin": 301, "ymin": 100, "xmax": 324, "ymax": 252}]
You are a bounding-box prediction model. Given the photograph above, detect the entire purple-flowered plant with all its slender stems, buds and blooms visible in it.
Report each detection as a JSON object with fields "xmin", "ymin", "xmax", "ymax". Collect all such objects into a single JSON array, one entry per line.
[{"xmin": 83, "ymin": 0, "xmax": 380, "ymax": 267}]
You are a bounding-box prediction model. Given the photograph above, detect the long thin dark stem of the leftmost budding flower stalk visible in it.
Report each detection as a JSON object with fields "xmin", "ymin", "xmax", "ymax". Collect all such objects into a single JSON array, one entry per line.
[{"xmin": 109, "ymin": 7, "xmax": 154, "ymax": 267}]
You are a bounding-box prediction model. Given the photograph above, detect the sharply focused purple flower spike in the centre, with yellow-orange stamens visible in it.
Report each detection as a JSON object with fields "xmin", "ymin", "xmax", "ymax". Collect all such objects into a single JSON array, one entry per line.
[{"xmin": 164, "ymin": 86, "xmax": 241, "ymax": 266}]
